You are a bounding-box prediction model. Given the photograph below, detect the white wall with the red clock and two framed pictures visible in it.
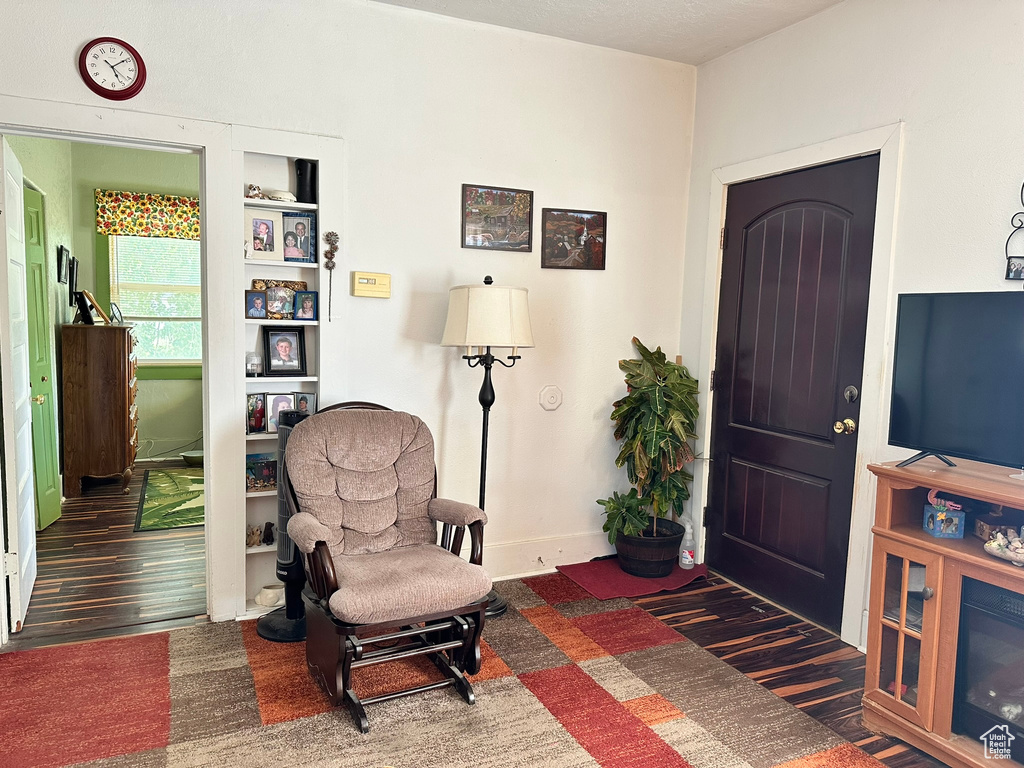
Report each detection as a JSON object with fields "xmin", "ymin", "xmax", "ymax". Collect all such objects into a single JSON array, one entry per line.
[{"xmin": 0, "ymin": 0, "xmax": 695, "ymax": 575}]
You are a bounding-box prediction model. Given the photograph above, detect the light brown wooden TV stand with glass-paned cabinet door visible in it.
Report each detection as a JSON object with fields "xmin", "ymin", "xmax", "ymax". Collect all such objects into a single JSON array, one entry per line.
[{"xmin": 863, "ymin": 458, "xmax": 1024, "ymax": 768}]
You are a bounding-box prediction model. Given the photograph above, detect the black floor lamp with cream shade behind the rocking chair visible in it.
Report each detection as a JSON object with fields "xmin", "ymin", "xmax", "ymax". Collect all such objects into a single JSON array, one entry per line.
[{"xmin": 441, "ymin": 274, "xmax": 534, "ymax": 616}]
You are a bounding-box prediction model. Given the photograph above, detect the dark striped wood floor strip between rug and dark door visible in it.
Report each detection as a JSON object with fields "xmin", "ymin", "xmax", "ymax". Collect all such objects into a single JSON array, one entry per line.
[{"xmin": 633, "ymin": 574, "xmax": 943, "ymax": 768}]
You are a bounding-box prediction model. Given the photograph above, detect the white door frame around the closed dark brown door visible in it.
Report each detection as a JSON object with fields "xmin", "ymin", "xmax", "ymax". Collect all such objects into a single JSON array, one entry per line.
[{"xmin": 690, "ymin": 123, "xmax": 903, "ymax": 650}]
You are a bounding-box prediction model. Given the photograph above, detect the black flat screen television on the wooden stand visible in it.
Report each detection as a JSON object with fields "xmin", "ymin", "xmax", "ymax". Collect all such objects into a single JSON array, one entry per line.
[{"xmin": 889, "ymin": 291, "xmax": 1024, "ymax": 468}]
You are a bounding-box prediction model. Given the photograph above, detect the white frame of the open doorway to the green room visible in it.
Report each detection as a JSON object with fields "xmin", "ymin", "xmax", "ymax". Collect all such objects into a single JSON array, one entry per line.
[{"xmin": 0, "ymin": 95, "xmax": 237, "ymax": 621}]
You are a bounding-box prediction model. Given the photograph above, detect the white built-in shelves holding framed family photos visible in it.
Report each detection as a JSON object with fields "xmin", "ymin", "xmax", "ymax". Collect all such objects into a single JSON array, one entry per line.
[{"xmin": 236, "ymin": 147, "xmax": 323, "ymax": 618}]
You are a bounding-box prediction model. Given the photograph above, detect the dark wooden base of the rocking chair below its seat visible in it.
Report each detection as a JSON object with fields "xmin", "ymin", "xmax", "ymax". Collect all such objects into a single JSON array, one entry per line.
[{"xmin": 302, "ymin": 592, "xmax": 487, "ymax": 733}]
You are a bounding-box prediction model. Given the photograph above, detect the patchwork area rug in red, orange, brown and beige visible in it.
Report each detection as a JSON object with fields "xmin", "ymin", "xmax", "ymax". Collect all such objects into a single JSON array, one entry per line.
[{"xmin": 0, "ymin": 573, "xmax": 881, "ymax": 768}]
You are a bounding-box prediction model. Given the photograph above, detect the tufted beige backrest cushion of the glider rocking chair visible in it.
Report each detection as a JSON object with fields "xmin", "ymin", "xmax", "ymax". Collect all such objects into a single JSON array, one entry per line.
[{"xmin": 286, "ymin": 411, "xmax": 437, "ymax": 561}]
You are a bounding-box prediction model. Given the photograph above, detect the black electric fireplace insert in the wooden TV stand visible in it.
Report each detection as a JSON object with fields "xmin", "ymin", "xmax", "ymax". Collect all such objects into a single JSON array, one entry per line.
[{"xmin": 953, "ymin": 578, "xmax": 1024, "ymax": 763}]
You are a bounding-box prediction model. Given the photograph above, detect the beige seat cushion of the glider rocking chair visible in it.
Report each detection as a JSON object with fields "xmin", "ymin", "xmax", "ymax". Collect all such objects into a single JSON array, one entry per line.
[{"xmin": 329, "ymin": 544, "xmax": 490, "ymax": 624}]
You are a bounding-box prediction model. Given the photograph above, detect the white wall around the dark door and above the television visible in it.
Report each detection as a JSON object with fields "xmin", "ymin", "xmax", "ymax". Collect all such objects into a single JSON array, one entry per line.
[{"xmin": 681, "ymin": 0, "xmax": 1024, "ymax": 641}]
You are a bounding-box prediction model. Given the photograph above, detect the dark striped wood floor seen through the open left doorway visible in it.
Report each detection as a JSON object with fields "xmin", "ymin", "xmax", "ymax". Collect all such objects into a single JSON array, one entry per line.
[{"xmin": 5, "ymin": 470, "xmax": 206, "ymax": 650}]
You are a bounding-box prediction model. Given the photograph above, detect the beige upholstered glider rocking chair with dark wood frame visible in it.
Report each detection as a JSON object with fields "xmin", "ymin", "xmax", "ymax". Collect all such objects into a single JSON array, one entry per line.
[{"xmin": 281, "ymin": 403, "xmax": 490, "ymax": 733}]
